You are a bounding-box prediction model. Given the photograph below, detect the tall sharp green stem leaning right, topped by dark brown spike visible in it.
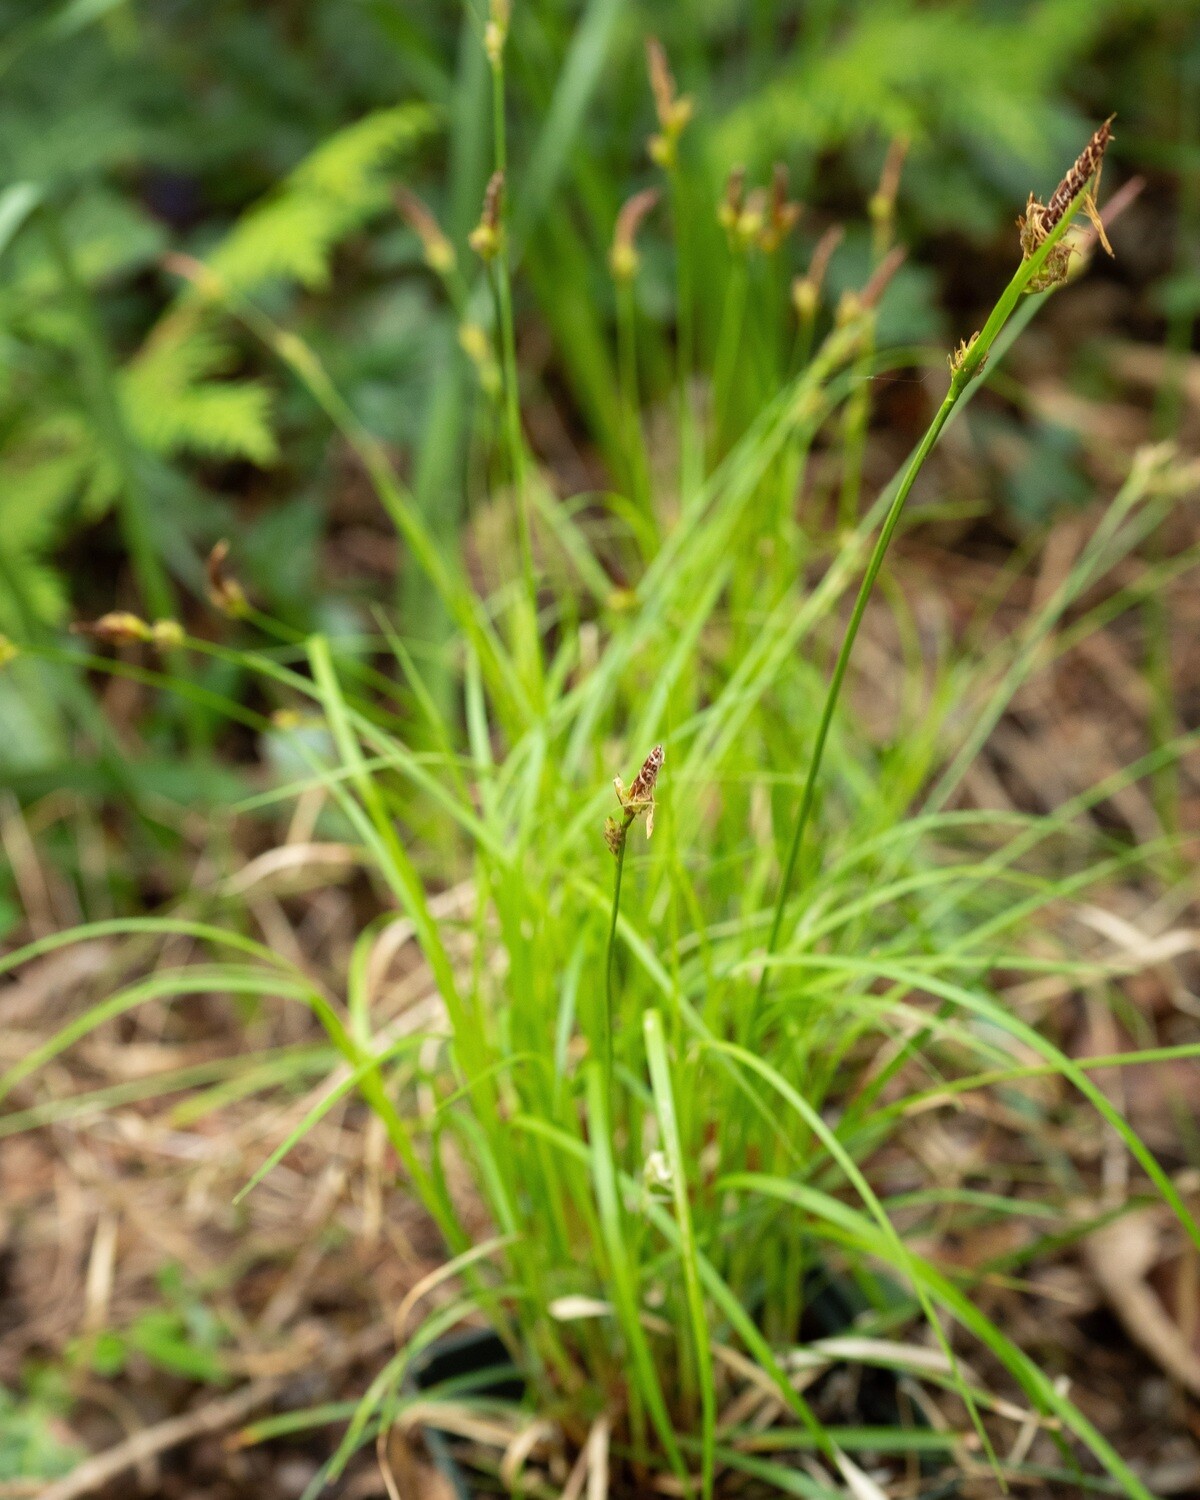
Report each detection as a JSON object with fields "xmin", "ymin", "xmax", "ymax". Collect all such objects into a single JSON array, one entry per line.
[{"xmin": 756, "ymin": 167, "xmax": 1091, "ymax": 1005}]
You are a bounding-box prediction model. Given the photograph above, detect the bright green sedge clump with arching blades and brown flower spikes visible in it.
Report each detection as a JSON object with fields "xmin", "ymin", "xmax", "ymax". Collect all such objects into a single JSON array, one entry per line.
[{"xmin": 0, "ymin": 67, "xmax": 1200, "ymax": 1500}]
